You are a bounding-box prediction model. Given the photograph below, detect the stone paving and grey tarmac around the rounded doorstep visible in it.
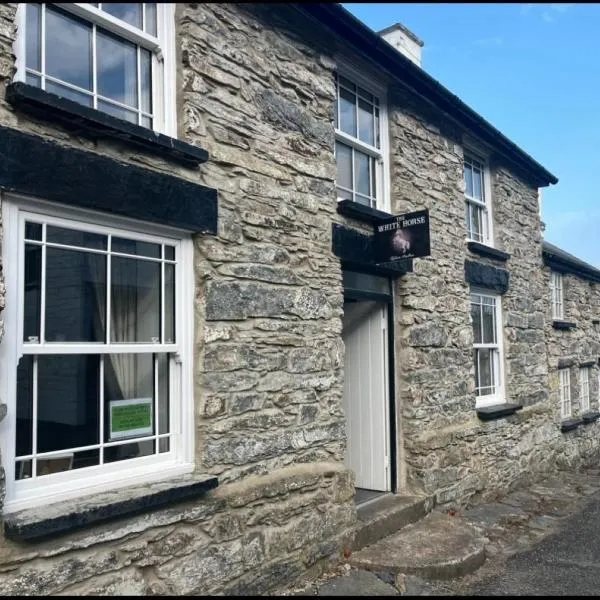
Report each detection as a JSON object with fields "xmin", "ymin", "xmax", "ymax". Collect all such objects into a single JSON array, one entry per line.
[{"xmin": 282, "ymin": 469, "xmax": 600, "ymax": 596}]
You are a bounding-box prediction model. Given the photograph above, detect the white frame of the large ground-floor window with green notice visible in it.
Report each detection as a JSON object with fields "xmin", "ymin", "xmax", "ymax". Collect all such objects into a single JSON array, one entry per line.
[{"xmin": 0, "ymin": 194, "xmax": 194, "ymax": 513}]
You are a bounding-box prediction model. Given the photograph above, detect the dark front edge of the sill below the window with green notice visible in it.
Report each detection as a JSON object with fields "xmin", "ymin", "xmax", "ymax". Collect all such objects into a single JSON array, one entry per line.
[{"xmin": 4, "ymin": 477, "xmax": 219, "ymax": 541}]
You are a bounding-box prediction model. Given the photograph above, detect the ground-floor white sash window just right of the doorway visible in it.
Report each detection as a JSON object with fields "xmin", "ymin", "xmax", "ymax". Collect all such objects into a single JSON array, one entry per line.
[{"xmin": 470, "ymin": 291, "xmax": 505, "ymax": 406}]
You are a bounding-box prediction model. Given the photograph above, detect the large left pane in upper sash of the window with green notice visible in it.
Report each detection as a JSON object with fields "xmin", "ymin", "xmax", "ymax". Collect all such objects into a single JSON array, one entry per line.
[{"xmin": 46, "ymin": 248, "xmax": 106, "ymax": 342}]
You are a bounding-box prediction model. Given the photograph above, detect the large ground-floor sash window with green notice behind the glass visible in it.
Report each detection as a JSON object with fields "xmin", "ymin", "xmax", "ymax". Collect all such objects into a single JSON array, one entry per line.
[{"xmin": 0, "ymin": 199, "xmax": 193, "ymax": 511}]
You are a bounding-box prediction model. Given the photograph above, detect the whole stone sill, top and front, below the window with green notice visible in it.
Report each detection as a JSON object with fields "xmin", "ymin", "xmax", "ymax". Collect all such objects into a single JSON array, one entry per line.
[{"xmin": 4, "ymin": 475, "xmax": 219, "ymax": 541}]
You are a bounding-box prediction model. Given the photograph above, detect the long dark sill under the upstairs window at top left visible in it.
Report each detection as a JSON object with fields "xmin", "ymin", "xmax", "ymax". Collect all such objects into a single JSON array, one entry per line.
[{"xmin": 6, "ymin": 81, "xmax": 208, "ymax": 167}]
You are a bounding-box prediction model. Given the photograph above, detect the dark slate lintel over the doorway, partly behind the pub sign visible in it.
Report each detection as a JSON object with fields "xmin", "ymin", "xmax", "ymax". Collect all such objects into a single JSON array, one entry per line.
[{"xmin": 331, "ymin": 223, "xmax": 413, "ymax": 277}]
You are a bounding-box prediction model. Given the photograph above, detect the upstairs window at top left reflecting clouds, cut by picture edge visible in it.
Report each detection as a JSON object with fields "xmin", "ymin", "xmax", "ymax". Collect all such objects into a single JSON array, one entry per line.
[{"xmin": 16, "ymin": 2, "xmax": 175, "ymax": 135}]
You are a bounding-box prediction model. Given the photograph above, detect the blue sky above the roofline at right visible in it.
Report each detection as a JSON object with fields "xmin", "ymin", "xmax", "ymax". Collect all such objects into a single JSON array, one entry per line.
[{"xmin": 343, "ymin": 3, "xmax": 600, "ymax": 268}]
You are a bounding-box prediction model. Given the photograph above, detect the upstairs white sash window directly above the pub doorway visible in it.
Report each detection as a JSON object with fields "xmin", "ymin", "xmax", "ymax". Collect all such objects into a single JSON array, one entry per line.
[{"xmin": 335, "ymin": 75, "xmax": 386, "ymax": 210}]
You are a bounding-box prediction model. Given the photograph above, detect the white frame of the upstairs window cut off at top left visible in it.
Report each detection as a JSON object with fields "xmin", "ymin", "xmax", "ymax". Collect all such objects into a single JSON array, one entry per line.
[{"xmin": 13, "ymin": 2, "xmax": 177, "ymax": 137}]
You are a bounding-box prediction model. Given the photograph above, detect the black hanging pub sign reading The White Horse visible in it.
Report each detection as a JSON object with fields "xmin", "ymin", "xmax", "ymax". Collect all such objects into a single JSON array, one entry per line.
[{"xmin": 374, "ymin": 209, "xmax": 431, "ymax": 263}]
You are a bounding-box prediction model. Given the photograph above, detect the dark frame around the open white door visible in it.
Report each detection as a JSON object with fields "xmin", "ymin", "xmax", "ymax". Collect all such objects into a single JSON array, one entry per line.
[{"xmin": 343, "ymin": 268, "xmax": 398, "ymax": 494}]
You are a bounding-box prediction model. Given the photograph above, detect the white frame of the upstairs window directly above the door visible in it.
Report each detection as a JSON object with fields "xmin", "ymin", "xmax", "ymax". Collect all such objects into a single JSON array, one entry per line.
[{"xmin": 334, "ymin": 59, "xmax": 391, "ymax": 212}]
